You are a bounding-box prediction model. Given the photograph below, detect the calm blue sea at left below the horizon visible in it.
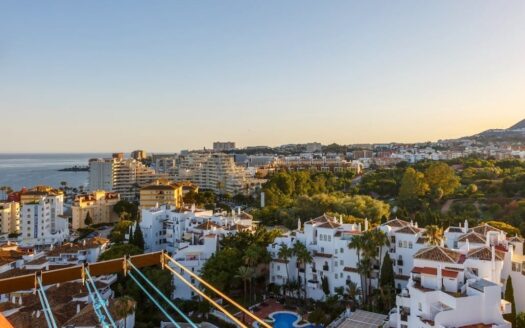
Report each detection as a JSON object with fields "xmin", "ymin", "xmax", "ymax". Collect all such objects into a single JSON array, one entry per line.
[{"xmin": 0, "ymin": 154, "xmax": 110, "ymax": 190}]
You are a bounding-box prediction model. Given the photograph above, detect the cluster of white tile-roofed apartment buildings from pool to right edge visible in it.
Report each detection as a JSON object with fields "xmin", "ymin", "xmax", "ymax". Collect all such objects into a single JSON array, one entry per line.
[{"xmin": 268, "ymin": 215, "xmax": 525, "ymax": 328}]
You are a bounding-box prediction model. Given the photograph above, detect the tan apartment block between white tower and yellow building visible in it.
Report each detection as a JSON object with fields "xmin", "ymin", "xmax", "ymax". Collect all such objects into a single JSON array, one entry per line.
[{"xmin": 71, "ymin": 190, "xmax": 120, "ymax": 230}]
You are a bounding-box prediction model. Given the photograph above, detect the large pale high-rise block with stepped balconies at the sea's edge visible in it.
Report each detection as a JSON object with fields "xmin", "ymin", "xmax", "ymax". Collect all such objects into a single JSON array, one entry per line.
[{"xmin": 89, "ymin": 157, "xmax": 163, "ymax": 201}]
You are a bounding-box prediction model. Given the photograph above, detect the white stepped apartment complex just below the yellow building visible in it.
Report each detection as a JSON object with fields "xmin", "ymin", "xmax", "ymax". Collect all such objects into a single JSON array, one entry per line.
[{"xmin": 139, "ymin": 206, "xmax": 254, "ymax": 299}]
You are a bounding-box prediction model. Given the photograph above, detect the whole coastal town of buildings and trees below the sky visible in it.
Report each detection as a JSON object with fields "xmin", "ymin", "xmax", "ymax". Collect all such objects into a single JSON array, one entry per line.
[{"xmin": 0, "ymin": 120, "xmax": 525, "ymax": 328}]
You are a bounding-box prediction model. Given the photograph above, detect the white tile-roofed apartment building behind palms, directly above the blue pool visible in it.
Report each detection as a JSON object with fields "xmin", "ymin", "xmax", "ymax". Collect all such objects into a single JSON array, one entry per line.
[{"xmin": 268, "ymin": 215, "xmax": 364, "ymax": 300}]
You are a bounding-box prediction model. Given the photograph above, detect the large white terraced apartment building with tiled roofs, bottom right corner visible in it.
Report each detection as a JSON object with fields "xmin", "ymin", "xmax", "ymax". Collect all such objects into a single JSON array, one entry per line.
[{"xmin": 390, "ymin": 221, "xmax": 525, "ymax": 327}]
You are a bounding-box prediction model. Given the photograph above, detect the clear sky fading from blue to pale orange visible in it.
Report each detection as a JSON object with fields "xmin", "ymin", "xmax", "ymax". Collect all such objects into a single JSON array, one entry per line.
[{"xmin": 0, "ymin": 0, "xmax": 525, "ymax": 152}]
